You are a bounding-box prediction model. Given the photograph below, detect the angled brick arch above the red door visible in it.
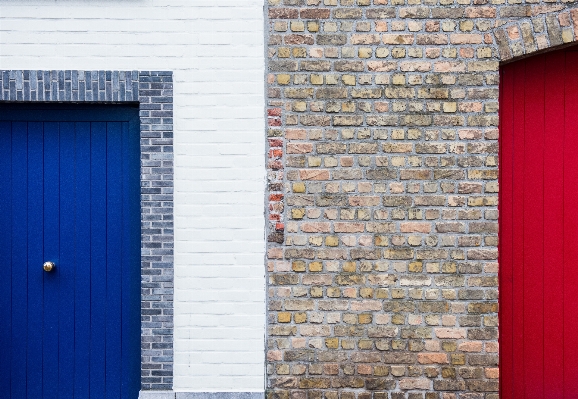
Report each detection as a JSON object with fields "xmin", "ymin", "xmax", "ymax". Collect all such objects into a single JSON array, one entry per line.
[{"xmin": 493, "ymin": 3, "xmax": 578, "ymax": 62}]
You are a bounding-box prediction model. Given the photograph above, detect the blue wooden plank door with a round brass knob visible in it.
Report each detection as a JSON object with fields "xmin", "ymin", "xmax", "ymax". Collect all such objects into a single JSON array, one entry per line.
[{"xmin": 0, "ymin": 104, "xmax": 140, "ymax": 399}]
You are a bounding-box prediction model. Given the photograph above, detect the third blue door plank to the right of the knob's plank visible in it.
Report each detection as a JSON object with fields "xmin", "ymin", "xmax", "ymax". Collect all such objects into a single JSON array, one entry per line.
[{"xmin": 90, "ymin": 122, "xmax": 107, "ymax": 399}]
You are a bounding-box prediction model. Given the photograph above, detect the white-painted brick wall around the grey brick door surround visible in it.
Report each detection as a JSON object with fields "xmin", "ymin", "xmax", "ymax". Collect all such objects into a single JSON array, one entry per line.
[{"xmin": 0, "ymin": 0, "xmax": 265, "ymax": 392}]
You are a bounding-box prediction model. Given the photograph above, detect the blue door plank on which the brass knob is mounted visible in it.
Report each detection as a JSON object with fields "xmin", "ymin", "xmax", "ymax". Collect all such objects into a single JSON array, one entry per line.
[{"xmin": 42, "ymin": 122, "xmax": 61, "ymax": 399}]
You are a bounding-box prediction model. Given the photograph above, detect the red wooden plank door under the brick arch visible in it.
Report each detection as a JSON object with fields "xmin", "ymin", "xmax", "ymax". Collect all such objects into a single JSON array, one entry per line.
[{"xmin": 499, "ymin": 47, "xmax": 578, "ymax": 399}]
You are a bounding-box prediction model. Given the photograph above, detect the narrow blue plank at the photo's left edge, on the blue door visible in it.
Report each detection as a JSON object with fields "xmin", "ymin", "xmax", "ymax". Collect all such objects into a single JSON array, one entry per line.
[{"xmin": 0, "ymin": 121, "xmax": 13, "ymax": 392}]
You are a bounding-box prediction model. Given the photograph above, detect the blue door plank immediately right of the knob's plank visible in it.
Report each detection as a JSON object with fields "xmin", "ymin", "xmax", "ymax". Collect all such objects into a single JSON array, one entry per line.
[{"xmin": 58, "ymin": 122, "xmax": 76, "ymax": 399}]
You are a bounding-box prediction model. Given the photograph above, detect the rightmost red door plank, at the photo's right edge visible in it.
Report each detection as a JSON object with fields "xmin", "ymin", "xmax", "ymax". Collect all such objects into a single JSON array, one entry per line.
[{"xmin": 562, "ymin": 51, "xmax": 578, "ymax": 398}]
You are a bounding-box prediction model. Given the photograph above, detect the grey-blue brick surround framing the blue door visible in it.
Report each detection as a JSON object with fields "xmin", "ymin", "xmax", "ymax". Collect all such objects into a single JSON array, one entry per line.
[{"xmin": 0, "ymin": 70, "xmax": 174, "ymax": 390}]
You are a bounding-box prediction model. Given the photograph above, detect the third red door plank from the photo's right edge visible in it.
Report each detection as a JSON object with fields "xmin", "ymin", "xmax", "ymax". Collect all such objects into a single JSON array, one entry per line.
[{"xmin": 516, "ymin": 56, "xmax": 545, "ymax": 398}]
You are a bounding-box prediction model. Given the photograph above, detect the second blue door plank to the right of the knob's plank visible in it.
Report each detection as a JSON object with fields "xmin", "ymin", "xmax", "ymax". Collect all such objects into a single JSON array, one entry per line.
[{"xmin": 73, "ymin": 122, "xmax": 91, "ymax": 398}]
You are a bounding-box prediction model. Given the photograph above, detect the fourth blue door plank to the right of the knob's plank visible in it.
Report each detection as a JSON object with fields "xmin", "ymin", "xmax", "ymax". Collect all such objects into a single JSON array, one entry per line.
[{"xmin": 106, "ymin": 122, "xmax": 123, "ymax": 398}]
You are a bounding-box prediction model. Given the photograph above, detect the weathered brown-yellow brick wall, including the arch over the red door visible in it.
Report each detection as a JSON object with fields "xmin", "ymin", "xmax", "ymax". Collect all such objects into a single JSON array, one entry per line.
[{"xmin": 267, "ymin": 0, "xmax": 578, "ymax": 399}]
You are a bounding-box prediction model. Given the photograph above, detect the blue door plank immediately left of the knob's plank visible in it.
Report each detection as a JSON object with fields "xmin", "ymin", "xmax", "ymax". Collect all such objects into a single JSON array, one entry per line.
[{"xmin": 26, "ymin": 122, "xmax": 45, "ymax": 398}]
